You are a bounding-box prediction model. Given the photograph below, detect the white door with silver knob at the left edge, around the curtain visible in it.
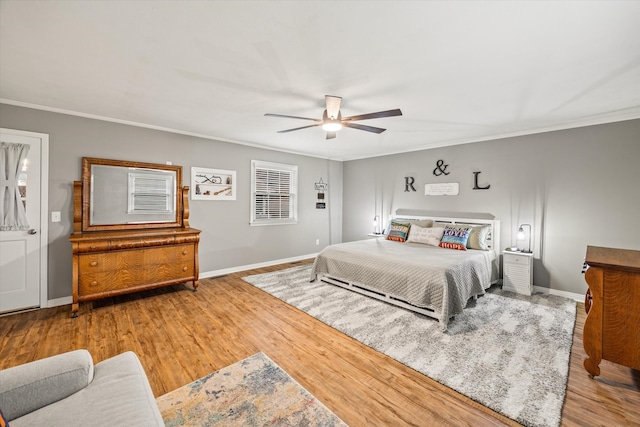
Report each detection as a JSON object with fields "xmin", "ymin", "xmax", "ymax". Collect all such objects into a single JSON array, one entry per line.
[{"xmin": 0, "ymin": 129, "xmax": 49, "ymax": 313}]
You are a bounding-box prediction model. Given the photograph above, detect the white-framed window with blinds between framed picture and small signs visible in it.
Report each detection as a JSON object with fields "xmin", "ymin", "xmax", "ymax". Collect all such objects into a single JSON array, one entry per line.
[{"xmin": 251, "ymin": 160, "xmax": 298, "ymax": 225}]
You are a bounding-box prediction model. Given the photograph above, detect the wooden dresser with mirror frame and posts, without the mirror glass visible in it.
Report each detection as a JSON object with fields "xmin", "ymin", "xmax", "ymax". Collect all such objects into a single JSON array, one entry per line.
[{"xmin": 69, "ymin": 159, "xmax": 200, "ymax": 317}]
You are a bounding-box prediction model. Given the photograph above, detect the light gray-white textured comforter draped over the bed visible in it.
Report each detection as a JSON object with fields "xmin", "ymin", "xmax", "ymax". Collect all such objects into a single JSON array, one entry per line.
[{"xmin": 312, "ymin": 239, "xmax": 495, "ymax": 329}]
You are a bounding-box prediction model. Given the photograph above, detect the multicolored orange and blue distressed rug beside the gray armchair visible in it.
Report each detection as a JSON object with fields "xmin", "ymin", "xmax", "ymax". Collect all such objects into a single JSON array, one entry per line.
[{"xmin": 156, "ymin": 353, "xmax": 346, "ymax": 427}]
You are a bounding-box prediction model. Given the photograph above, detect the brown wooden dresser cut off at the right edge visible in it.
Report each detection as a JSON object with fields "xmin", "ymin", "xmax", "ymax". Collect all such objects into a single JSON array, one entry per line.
[{"xmin": 582, "ymin": 246, "xmax": 640, "ymax": 378}]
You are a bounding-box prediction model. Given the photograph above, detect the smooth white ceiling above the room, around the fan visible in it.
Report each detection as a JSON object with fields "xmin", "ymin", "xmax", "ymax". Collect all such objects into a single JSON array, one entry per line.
[{"xmin": 0, "ymin": 0, "xmax": 640, "ymax": 160}]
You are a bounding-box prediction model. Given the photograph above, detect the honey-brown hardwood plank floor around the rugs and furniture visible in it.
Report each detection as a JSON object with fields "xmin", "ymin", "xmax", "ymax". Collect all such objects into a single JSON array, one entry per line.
[{"xmin": 0, "ymin": 263, "xmax": 640, "ymax": 426}]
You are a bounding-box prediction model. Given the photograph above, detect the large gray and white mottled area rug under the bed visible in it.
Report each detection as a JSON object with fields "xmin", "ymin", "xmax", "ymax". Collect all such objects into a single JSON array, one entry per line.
[{"xmin": 243, "ymin": 265, "xmax": 576, "ymax": 426}]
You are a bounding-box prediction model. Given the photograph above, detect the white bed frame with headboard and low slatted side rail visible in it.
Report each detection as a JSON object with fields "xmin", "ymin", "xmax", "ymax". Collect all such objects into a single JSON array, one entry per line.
[{"xmin": 317, "ymin": 209, "xmax": 500, "ymax": 319}]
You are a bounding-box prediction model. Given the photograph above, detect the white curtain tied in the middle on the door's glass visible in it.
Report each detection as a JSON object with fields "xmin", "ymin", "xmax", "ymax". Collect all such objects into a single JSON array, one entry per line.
[{"xmin": 0, "ymin": 142, "xmax": 30, "ymax": 231}]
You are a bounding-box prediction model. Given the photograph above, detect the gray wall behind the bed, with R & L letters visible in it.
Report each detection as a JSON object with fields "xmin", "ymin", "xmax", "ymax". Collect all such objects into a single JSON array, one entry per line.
[{"xmin": 343, "ymin": 120, "xmax": 640, "ymax": 294}]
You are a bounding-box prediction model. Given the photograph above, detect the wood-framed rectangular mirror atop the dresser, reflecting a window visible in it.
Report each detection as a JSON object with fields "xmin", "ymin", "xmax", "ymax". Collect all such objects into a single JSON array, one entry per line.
[{"xmin": 79, "ymin": 157, "xmax": 188, "ymax": 232}]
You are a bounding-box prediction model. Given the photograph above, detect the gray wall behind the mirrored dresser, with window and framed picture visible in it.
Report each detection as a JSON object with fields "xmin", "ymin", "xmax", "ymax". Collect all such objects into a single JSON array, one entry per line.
[{"xmin": 0, "ymin": 104, "xmax": 342, "ymax": 299}]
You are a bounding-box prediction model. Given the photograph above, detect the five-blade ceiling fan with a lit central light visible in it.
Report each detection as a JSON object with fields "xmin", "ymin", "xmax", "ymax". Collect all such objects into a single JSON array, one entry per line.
[{"xmin": 265, "ymin": 95, "xmax": 402, "ymax": 139}]
